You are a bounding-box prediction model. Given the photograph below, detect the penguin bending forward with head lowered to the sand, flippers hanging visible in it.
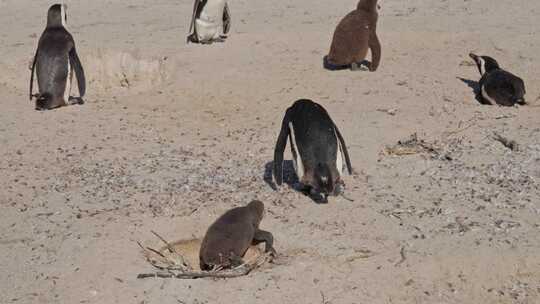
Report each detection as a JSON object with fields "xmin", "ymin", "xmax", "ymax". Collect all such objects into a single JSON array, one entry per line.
[{"xmin": 274, "ymin": 99, "xmax": 352, "ymax": 202}]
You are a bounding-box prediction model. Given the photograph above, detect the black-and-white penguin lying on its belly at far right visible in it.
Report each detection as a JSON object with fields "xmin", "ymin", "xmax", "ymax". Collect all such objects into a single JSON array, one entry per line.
[{"xmin": 469, "ymin": 53, "xmax": 526, "ymax": 106}]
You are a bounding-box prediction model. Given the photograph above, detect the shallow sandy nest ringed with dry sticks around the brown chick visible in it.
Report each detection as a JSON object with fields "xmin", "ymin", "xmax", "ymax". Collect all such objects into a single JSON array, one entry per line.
[{"xmin": 137, "ymin": 231, "xmax": 272, "ymax": 279}]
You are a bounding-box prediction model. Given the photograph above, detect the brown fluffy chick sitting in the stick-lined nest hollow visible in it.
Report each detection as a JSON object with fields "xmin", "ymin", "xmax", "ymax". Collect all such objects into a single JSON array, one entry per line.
[{"xmin": 199, "ymin": 201, "xmax": 275, "ymax": 270}]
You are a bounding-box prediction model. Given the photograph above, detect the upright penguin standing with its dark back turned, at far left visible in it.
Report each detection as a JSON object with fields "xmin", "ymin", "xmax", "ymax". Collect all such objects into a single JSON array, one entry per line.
[{"xmin": 30, "ymin": 4, "xmax": 86, "ymax": 110}]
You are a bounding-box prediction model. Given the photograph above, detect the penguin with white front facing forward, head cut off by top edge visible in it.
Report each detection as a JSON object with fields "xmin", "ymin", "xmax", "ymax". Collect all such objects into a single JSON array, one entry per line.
[{"xmin": 187, "ymin": 0, "xmax": 231, "ymax": 44}]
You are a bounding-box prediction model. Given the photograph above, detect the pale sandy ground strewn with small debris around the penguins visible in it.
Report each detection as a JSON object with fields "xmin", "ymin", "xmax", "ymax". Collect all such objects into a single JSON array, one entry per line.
[{"xmin": 0, "ymin": 0, "xmax": 540, "ymax": 304}]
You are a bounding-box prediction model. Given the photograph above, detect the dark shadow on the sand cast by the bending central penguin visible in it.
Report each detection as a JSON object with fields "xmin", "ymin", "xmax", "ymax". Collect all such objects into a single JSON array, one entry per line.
[{"xmin": 263, "ymin": 160, "xmax": 328, "ymax": 204}]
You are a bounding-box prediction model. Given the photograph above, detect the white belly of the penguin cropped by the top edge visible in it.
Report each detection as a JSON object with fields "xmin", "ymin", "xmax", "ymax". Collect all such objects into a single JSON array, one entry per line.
[{"xmin": 195, "ymin": 0, "xmax": 225, "ymax": 41}]
